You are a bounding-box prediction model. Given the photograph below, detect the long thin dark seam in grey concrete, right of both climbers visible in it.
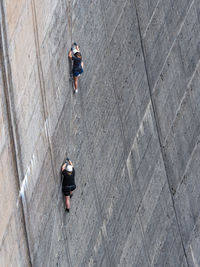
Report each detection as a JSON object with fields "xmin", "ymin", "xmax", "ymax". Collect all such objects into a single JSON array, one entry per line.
[{"xmin": 134, "ymin": 0, "xmax": 189, "ymax": 266}]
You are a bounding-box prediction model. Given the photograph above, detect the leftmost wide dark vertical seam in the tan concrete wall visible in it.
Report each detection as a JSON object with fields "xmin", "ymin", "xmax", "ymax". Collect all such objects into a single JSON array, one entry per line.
[{"xmin": 0, "ymin": 1, "xmax": 32, "ymax": 266}]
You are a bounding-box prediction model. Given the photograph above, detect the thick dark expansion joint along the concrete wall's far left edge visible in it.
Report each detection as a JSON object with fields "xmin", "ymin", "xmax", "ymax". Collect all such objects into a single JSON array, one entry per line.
[{"xmin": 0, "ymin": 1, "xmax": 32, "ymax": 266}]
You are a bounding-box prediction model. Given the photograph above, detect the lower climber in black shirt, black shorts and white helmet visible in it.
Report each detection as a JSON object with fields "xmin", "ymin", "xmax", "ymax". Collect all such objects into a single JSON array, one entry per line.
[{"xmin": 62, "ymin": 159, "xmax": 76, "ymax": 212}]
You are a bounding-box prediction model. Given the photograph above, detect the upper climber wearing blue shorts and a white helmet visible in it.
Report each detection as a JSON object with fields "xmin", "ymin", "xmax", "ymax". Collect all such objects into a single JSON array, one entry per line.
[{"xmin": 68, "ymin": 43, "xmax": 84, "ymax": 93}]
